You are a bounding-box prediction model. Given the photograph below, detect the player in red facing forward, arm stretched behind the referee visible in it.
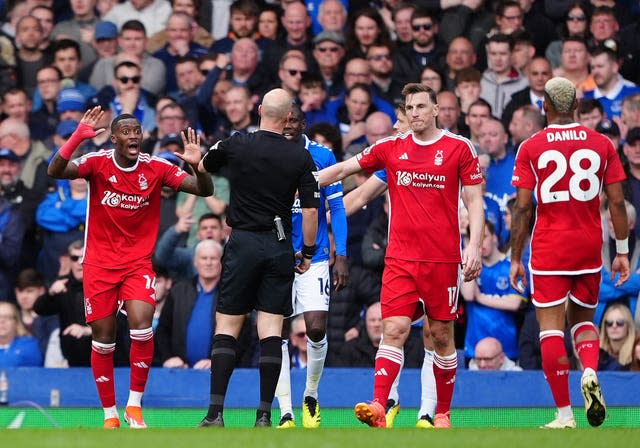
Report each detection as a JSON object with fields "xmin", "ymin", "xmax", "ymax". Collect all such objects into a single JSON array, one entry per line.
[{"xmin": 320, "ymin": 83, "xmax": 484, "ymax": 428}]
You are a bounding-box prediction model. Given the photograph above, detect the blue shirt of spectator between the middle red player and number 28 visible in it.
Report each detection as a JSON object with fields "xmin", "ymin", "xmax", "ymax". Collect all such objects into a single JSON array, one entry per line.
[{"xmin": 464, "ymin": 258, "xmax": 524, "ymax": 359}]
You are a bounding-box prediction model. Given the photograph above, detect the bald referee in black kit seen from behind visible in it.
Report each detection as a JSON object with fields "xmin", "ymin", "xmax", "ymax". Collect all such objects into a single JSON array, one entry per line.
[{"xmin": 198, "ymin": 89, "xmax": 320, "ymax": 427}]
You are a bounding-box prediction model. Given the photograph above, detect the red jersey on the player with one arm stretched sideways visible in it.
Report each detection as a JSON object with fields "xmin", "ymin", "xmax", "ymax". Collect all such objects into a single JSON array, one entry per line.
[{"xmin": 357, "ymin": 131, "xmax": 482, "ymax": 263}]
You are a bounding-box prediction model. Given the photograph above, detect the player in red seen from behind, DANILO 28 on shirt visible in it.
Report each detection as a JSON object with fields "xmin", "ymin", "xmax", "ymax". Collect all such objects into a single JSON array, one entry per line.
[{"xmin": 510, "ymin": 77, "xmax": 629, "ymax": 428}]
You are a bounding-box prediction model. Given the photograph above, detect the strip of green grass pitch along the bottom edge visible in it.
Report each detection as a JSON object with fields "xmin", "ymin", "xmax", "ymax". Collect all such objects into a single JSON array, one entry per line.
[{"xmin": 0, "ymin": 428, "xmax": 640, "ymax": 448}]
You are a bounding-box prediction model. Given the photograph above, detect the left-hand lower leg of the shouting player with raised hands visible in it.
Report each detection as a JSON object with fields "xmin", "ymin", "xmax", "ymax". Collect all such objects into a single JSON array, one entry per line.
[{"xmin": 89, "ymin": 315, "xmax": 120, "ymax": 428}]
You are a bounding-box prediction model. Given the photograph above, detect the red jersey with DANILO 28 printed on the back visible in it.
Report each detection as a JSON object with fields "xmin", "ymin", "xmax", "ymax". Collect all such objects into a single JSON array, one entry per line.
[{"xmin": 512, "ymin": 123, "xmax": 625, "ymax": 275}]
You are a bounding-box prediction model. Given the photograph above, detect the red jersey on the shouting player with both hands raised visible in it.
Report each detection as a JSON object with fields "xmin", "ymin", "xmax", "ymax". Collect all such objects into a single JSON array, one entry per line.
[{"xmin": 72, "ymin": 149, "xmax": 188, "ymax": 269}]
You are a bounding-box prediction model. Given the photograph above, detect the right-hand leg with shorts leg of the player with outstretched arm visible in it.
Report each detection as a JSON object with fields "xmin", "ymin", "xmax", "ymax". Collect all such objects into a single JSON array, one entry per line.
[{"xmin": 419, "ymin": 263, "xmax": 461, "ymax": 428}]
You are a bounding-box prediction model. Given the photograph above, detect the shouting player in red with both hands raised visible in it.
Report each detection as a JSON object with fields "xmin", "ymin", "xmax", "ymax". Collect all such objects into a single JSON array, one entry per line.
[{"xmin": 48, "ymin": 106, "xmax": 213, "ymax": 428}]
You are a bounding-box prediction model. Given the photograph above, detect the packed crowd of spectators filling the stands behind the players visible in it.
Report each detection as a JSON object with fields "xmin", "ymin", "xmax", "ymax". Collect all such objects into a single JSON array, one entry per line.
[{"xmin": 0, "ymin": 0, "xmax": 640, "ymax": 378}]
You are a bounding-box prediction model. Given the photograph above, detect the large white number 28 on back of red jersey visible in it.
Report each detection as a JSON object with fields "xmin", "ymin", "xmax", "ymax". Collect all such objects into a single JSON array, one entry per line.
[{"xmin": 538, "ymin": 149, "xmax": 600, "ymax": 203}]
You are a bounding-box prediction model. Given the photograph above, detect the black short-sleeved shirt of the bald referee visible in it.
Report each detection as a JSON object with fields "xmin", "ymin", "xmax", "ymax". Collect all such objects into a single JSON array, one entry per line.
[{"xmin": 203, "ymin": 130, "xmax": 320, "ymax": 232}]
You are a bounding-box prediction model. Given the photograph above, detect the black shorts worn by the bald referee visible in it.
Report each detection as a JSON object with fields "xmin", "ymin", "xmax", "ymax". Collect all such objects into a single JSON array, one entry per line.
[{"xmin": 216, "ymin": 230, "xmax": 295, "ymax": 316}]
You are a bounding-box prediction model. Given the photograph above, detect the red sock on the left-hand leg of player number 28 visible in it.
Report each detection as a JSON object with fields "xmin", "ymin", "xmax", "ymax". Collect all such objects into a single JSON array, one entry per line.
[{"xmin": 540, "ymin": 330, "xmax": 570, "ymax": 408}]
